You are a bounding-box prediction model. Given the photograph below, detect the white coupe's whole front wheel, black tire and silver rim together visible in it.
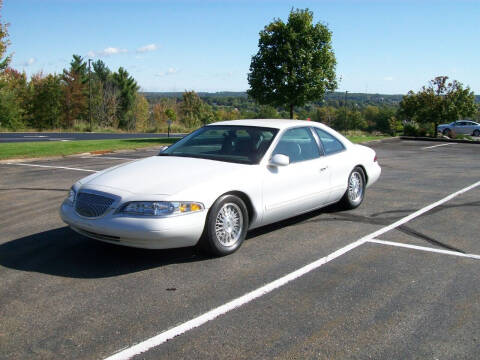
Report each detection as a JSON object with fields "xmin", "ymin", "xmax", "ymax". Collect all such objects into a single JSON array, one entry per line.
[{"xmin": 199, "ymin": 195, "xmax": 249, "ymax": 256}]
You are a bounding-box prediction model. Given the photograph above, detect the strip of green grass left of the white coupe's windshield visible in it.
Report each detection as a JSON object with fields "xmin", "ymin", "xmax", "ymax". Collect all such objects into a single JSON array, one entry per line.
[{"xmin": 0, "ymin": 138, "xmax": 178, "ymax": 160}]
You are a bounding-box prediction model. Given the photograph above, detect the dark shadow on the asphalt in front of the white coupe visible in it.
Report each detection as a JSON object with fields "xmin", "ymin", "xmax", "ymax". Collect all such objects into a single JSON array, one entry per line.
[{"xmin": 0, "ymin": 226, "xmax": 204, "ymax": 279}]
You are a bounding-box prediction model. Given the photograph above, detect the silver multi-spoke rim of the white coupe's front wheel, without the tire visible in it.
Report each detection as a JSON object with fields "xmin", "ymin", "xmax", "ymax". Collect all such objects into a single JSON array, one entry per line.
[{"xmin": 215, "ymin": 202, "xmax": 243, "ymax": 246}]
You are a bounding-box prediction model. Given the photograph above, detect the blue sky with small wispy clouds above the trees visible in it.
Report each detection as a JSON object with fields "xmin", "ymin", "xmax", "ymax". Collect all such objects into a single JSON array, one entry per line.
[{"xmin": 1, "ymin": 0, "xmax": 480, "ymax": 94}]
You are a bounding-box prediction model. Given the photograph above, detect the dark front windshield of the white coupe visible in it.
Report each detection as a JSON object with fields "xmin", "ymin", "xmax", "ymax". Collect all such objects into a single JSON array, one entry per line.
[{"xmin": 158, "ymin": 125, "xmax": 278, "ymax": 164}]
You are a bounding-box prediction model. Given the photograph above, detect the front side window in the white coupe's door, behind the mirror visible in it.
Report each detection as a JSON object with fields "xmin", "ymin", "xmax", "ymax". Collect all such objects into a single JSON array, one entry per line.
[{"xmin": 272, "ymin": 128, "xmax": 320, "ymax": 163}]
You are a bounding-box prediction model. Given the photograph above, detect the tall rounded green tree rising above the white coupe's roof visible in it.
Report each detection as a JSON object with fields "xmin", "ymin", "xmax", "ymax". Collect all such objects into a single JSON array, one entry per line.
[{"xmin": 247, "ymin": 9, "xmax": 337, "ymax": 119}]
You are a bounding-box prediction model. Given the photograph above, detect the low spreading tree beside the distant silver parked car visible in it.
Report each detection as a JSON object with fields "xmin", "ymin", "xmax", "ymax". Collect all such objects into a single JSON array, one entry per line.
[{"xmin": 398, "ymin": 76, "xmax": 477, "ymax": 136}]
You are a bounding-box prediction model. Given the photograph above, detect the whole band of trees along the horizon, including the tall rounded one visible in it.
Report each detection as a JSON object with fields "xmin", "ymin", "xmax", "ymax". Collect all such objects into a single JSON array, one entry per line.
[{"xmin": 0, "ymin": 0, "xmax": 479, "ymax": 136}]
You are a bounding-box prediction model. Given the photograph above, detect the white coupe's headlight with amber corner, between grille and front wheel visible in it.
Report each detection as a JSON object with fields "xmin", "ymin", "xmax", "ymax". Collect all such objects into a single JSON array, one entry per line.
[{"xmin": 119, "ymin": 201, "xmax": 205, "ymax": 216}]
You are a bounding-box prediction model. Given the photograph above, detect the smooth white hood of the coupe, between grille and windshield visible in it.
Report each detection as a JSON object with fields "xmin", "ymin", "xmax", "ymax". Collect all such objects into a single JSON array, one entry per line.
[{"xmin": 81, "ymin": 156, "xmax": 251, "ymax": 195}]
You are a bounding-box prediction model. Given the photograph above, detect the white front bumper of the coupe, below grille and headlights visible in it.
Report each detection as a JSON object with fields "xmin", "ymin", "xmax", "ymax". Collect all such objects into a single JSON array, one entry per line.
[{"xmin": 60, "ymin": 201, "xmax": 207, "ymax": 249}]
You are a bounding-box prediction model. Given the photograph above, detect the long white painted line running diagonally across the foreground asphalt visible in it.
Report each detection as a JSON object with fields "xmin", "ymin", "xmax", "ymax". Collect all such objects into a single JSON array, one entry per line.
[{"xmin": 105, "ymin": 181, "xmax": 480, "ymax": 360}]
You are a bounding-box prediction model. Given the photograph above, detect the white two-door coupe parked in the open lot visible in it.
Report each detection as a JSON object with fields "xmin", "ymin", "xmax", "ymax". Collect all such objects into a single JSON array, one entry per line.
[{"xmin": 60, "ymin": 120, "xmax": 381, "ymax": 255}]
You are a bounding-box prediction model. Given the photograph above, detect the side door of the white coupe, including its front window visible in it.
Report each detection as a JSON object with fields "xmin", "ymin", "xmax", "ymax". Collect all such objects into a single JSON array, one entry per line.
[{"xmin": 263, "ymin": 127, "xmax": 330, "ymax": 224}]
